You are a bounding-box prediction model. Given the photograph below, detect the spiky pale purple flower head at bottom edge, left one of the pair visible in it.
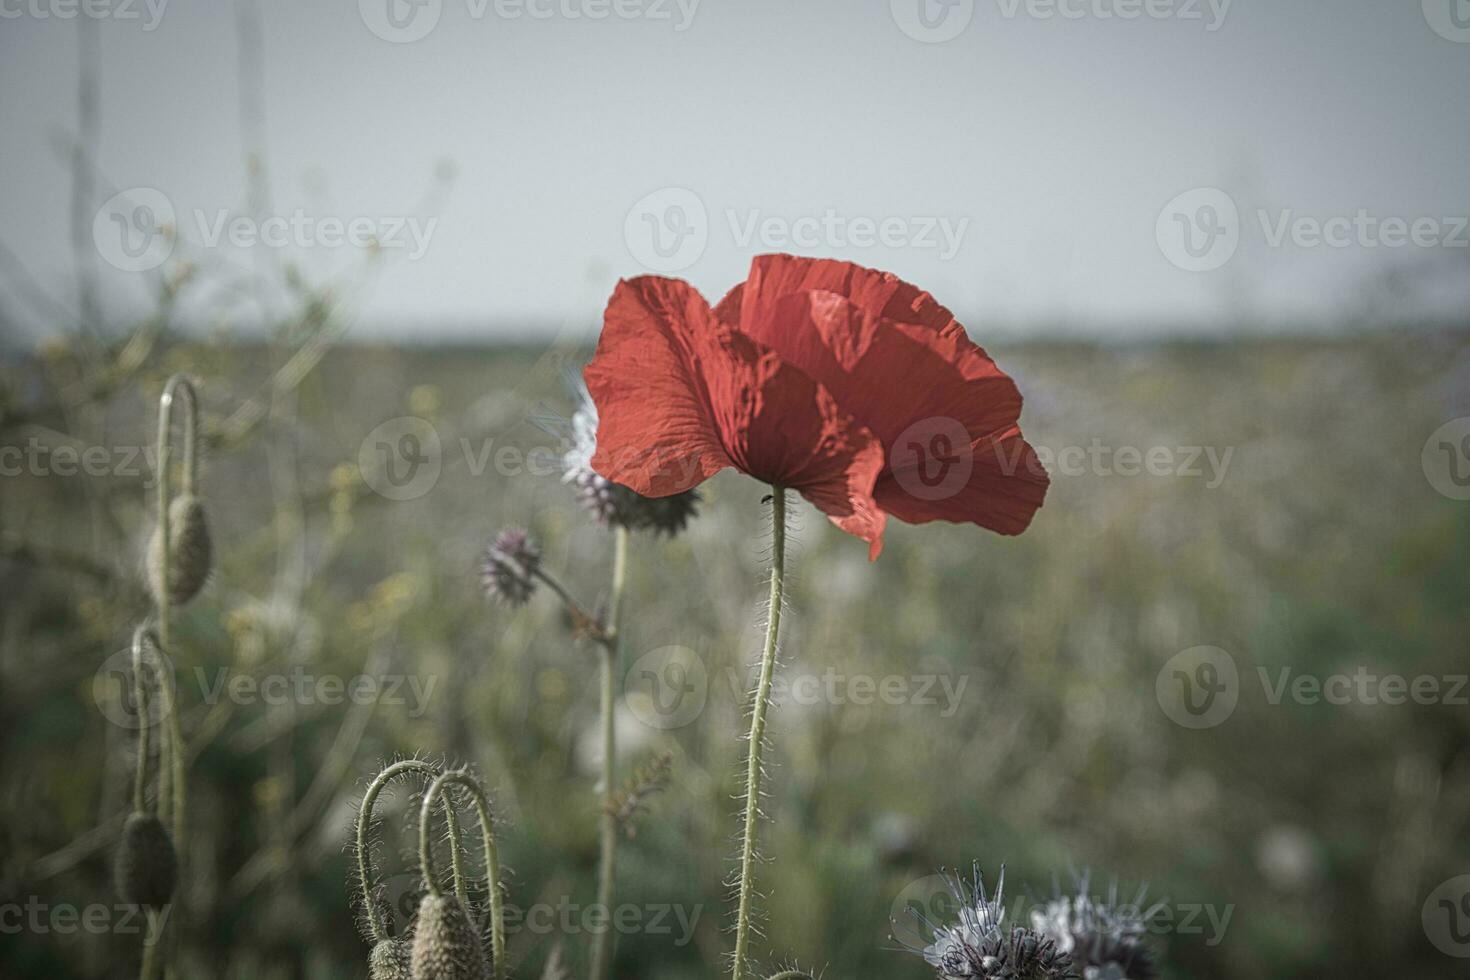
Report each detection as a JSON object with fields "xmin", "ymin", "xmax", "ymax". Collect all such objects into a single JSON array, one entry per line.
[{"xmin": 914, "ymin": 862, "xmax": 1078, "ymax": 980}]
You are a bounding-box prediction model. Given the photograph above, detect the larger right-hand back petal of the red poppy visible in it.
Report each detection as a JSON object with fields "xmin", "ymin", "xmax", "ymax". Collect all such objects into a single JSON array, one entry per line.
[{"xmin": 716, "ymin": 256, "xmax": 1050, "ymax": 535}]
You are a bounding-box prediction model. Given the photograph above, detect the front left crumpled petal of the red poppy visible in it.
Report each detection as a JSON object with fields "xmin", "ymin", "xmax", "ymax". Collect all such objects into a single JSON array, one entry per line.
[{"xmin": 585, "ymin": 276, "xmax": 886, "ymax": 554}]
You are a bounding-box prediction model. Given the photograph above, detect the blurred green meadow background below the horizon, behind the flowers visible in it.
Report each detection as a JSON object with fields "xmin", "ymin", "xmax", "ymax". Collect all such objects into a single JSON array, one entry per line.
[{"xmin": 0, "ymin": 325, "xmax": 1470, "ymax": 980}]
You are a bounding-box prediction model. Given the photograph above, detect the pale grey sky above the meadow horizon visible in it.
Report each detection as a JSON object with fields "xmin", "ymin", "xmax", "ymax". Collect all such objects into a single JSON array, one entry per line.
[{"xmin": 0, "ymin": 0, "xmax": 1470, "ymax": 339}]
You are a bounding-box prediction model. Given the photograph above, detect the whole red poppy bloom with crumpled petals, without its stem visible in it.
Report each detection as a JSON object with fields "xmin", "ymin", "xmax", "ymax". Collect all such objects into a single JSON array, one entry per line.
[{"xmin": 585, "ymin": 256, "xmax": 1048, "ymax": 558}]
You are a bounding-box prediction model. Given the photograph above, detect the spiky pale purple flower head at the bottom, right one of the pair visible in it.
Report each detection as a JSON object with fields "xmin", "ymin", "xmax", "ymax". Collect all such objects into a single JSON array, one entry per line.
[{"xmin": 1030, "ymin": 876, "xmax": 1158, "ymax": 980}]
